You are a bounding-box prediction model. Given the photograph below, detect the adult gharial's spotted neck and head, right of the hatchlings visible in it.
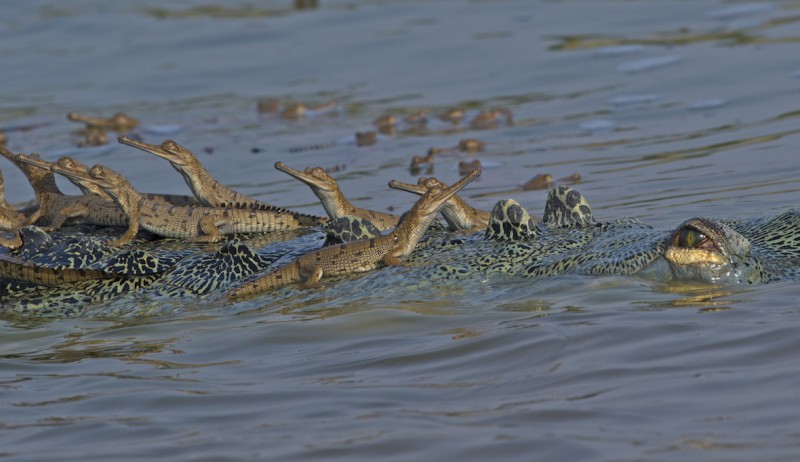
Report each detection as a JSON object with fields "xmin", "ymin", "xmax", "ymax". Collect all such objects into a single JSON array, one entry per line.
[{"xmin": 400, "ymin": 186, "xmax": 800, "ymax": 284}]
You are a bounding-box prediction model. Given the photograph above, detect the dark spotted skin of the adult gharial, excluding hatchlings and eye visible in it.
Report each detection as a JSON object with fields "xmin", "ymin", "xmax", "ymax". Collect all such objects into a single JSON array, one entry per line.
[{"xmin": 0, "ymin": 186, "xmax": 800, "ymax": 316}]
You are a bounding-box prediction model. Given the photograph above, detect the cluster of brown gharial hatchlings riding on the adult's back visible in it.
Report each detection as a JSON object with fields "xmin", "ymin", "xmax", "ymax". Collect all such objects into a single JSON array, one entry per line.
[{"xmin": 0, "ymin": 113, "xmax": 500, "ymax": 295}]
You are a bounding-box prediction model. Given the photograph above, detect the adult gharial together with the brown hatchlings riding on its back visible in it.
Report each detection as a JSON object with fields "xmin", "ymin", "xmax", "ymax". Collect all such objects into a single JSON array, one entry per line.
[{"xmin": 0, "ymin": 129, "xmax": 800, "ymax": 314}]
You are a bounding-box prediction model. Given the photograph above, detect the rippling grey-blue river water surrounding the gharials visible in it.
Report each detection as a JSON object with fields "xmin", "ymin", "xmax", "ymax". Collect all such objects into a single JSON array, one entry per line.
[{"xmin": 0, "ymin": 0, "xmax": 800, "ymax": 461}]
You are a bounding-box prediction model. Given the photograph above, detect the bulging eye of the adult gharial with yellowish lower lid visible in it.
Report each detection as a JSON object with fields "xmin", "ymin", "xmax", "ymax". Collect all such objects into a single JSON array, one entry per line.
[{"xmin": 664, "ymin": 218, "xmax": 763, "ymax": 284}]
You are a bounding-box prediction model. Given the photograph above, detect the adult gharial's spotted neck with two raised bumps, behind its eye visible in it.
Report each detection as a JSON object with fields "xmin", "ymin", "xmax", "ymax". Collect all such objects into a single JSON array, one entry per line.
[{"xmin": 412, "ymin": 186, "xmax": 668, "ymax": 279}]
